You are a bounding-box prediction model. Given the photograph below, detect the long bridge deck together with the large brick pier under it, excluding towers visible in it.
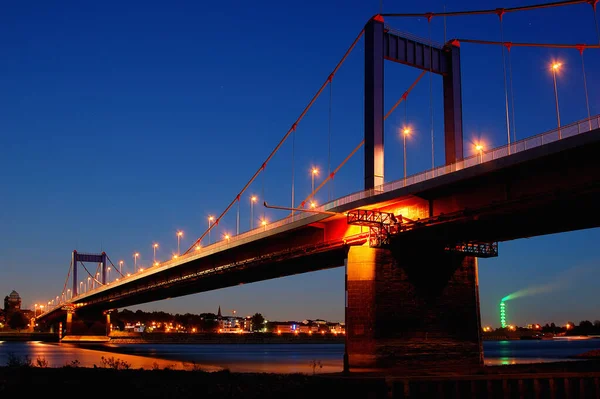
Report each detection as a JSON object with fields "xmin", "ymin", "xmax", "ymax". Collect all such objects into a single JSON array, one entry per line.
[{"xmin": 38, "ymin": 117, "xmax": 600, "ymax": 376}]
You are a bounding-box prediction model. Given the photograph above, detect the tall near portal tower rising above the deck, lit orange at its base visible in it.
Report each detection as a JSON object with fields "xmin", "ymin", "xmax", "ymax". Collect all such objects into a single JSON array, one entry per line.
[{"xmin": 364, "ymin": 15, "xmax": 463, "ymax": 190}]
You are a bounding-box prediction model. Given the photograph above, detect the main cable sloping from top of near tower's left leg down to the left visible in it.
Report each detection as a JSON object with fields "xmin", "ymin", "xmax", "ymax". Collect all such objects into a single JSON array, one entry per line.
[{"xmin": 183, "ymin": 28, "xmax": 365, "ymax": 255}]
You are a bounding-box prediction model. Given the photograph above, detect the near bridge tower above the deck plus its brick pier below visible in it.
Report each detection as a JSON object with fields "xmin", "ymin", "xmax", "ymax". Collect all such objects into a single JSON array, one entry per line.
[{"xmin": 344, "ymin": 15, "xmax": 483, "ymax": 373}]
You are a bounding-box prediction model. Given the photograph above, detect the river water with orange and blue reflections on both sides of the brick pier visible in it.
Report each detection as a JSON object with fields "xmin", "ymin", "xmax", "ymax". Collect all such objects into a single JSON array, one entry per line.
[{"xmin": 0, "ymin": 339, "xmax": 600, "ymax": 373}]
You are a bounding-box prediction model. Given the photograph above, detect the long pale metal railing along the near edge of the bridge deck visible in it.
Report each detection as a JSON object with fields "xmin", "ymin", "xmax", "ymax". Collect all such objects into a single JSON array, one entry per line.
[{"xmin": 48, "ymin": 115, "xmax": 600, "ymax": 311}]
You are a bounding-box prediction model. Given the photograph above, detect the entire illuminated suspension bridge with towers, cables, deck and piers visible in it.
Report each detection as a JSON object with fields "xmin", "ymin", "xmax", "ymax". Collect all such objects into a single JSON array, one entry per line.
[{"xmin": 36, "ymin": 0, "xmax": 600, "ymax": 376}]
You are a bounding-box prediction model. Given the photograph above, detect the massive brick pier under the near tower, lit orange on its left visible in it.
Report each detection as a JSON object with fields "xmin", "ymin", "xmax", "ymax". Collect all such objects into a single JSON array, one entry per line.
[{"xmin": 346, "ymin": 247, "xmax": 483, "ymax": 374}]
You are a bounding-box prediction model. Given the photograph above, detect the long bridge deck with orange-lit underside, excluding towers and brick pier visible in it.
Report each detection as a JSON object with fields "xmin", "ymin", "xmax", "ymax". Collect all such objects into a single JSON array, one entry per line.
[{"xmin": 38, "ymin": 117, "xmax": 600, "ymax": 320}]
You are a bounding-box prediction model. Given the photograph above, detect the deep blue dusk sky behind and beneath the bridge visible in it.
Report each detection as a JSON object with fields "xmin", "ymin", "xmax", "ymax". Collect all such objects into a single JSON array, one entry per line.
[{"xmin": 0, "ymin": 0, "xmax": 600, "ymax": 325}]
